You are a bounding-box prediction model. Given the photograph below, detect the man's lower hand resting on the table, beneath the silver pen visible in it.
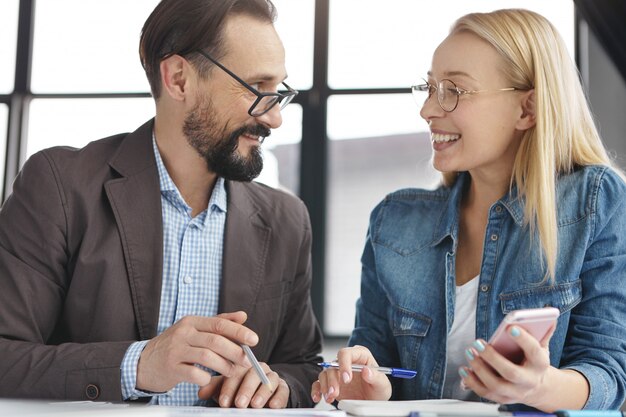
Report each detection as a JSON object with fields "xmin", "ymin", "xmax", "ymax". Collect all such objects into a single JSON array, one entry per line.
[{"xmin": 198, "ymin": 362, "xmax": 289, "ymax": 408}]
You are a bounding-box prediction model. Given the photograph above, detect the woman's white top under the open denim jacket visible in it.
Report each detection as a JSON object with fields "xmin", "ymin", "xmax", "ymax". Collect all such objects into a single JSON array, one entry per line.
[{"xmin": 443, "ymin": 276, "xmax": 478, "ymax": 400}]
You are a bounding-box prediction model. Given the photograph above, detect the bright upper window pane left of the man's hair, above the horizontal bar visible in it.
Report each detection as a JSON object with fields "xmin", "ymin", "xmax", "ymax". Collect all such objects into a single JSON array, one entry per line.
[{"xmin": 32, "ymin": 0, "xmax": 158, "ymax": 93}]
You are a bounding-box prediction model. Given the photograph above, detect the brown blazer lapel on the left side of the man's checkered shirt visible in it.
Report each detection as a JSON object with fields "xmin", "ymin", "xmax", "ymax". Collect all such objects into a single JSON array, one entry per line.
[{"xmin": 105, "ymin": 120, "xmax": 163, "ymax": 340}]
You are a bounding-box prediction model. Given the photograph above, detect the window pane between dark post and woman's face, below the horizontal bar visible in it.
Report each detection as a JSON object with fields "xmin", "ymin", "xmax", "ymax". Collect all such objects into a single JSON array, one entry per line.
[{"xmin": 324, "ymin": 94, "xmax": 439, "ymax": 335}]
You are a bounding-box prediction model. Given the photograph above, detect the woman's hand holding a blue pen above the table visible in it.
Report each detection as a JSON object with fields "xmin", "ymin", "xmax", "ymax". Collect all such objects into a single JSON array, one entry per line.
[{"xmin": 311, "ymin": 346, "xmax": 391, "ymax": 403}]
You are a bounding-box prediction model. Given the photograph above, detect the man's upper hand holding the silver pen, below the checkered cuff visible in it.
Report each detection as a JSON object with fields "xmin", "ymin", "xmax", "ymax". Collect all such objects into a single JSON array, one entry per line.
[{"xmin": 137, "ymin": 311, "xmax": 259, "ymax": 392}]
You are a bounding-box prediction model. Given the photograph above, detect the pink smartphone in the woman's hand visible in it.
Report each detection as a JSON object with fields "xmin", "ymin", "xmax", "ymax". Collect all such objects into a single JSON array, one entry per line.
[{"xmin": 489, "ymin": 307, "xmax": 559, "ymax": 363}]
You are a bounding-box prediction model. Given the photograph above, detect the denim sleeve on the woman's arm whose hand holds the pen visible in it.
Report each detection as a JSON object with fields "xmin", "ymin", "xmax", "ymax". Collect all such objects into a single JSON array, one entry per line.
[{"xmin": 348, "ymin": 202, "xmax": 400, "ymax": 391}]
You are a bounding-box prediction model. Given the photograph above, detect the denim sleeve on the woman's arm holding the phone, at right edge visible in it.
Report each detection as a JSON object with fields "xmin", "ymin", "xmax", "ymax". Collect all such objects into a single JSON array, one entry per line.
[{"xmin": 561, "ymin": 169, "xmax": 626, "ymax": 410}]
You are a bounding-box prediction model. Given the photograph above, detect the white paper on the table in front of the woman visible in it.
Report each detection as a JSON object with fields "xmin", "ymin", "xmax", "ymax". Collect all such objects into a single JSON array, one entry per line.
[{"xmin": 339, "ymin": 400, "xmax": 500, "ymax": 417}]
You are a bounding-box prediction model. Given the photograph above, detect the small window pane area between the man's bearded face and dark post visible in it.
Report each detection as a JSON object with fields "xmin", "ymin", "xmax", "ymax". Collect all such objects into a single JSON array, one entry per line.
[{"xmin": 257, "ymin": 103, "xmax": 302, "ymax": 194}]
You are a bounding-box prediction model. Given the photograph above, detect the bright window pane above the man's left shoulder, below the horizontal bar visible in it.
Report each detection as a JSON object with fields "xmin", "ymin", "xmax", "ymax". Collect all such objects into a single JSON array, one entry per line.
[{"xmin": 26, "ymin": 98, "xmax": 154, "ymax": 157}]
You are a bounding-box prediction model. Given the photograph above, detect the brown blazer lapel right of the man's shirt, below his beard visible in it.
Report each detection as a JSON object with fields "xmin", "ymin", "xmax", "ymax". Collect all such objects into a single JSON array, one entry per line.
[{"xmin": 219, "ymin": 181, "xmax": 271, "ymax": 312}]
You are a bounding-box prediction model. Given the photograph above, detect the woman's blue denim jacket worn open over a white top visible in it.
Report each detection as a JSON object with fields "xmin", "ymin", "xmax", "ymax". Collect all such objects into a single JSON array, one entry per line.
[{"xmin": 349, "ymin": 166, "xmax": 626, "ymax": 409}]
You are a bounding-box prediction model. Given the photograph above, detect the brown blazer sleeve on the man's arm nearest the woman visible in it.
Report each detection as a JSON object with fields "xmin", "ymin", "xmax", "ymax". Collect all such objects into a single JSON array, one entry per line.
[{"xmin": 268, "ymin": 198, "xmax": 322, "ymax": 407}]
